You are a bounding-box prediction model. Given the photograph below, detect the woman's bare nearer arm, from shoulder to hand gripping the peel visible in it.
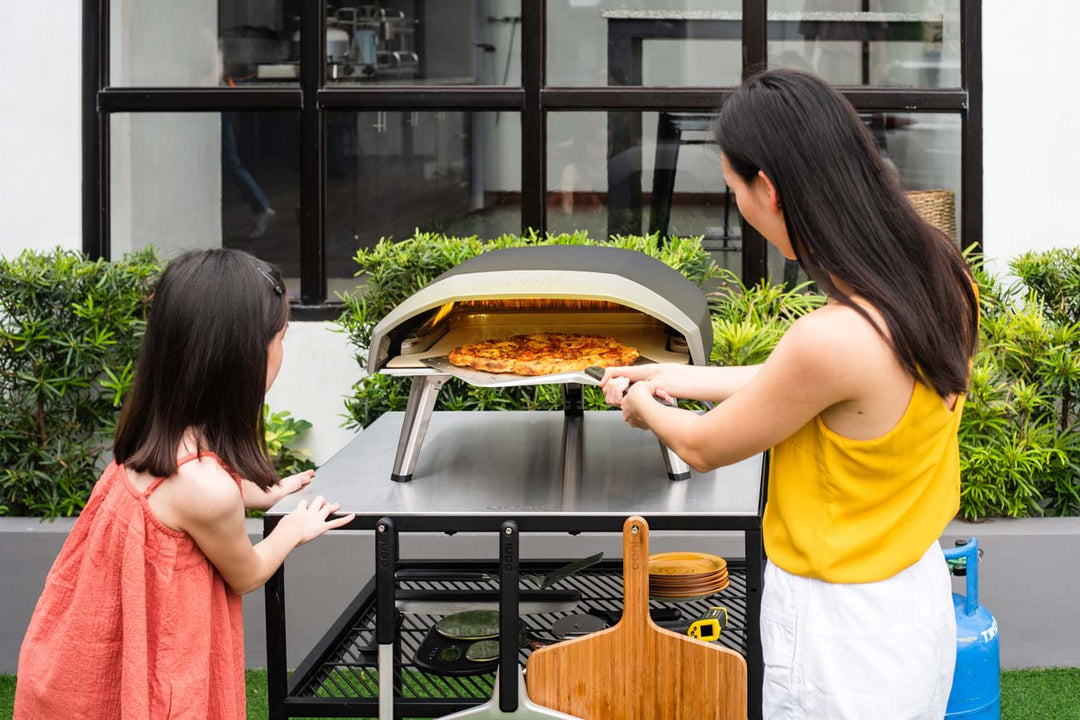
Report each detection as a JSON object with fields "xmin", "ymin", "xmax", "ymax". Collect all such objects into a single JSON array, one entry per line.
[{"xmin": 622, "ymin": 311, "xmax": 868, "ymax": 472}]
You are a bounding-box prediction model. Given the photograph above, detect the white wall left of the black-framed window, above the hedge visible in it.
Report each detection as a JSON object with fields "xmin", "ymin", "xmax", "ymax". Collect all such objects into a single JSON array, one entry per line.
[{"xmin": 0, "ymin": 0, "xmax": 82, "ymax": 255}]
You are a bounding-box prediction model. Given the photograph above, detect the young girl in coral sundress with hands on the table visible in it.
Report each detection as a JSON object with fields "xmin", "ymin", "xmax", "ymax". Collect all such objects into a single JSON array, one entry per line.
[{"xmin": 14, "ymin": 249, "xmax": 352, "ymax": 720}]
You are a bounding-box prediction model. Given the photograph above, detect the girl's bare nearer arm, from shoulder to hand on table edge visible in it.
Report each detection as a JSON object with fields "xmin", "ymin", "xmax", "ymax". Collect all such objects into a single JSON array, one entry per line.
[{"xmin": 177, "ymin": 463, "xmax": 353, "ymax": 595}]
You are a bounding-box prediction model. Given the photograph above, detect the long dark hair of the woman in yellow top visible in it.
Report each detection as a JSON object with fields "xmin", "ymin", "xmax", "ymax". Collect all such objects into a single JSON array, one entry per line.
[{"xmin": 715, "ymin": 70, "xmax": 978, "ymax": 397}]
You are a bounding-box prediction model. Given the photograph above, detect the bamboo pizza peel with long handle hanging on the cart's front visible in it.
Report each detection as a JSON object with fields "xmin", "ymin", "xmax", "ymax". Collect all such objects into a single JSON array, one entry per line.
[{"xmin": 526, "ymin": 516, "xmax": 746, "ymax": 720}]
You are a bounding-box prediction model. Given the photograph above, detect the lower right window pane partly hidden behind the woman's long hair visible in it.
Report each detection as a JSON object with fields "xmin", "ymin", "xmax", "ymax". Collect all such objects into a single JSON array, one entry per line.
[{"xmin": 769, "ymin": 112, "xmax": 962, "ymax": 283}]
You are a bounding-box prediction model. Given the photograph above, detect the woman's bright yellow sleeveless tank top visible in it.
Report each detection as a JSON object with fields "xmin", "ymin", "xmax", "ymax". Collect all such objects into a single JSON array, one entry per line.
[{"xmin": 762, "ymin": 382, "xmax": 964, "ymax": 583}]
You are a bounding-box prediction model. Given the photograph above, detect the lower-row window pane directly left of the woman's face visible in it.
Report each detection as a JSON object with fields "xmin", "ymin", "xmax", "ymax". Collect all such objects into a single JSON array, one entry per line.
[{"xmin": 548, "ymin": 111, "xmax": 742, "ymax": 273}]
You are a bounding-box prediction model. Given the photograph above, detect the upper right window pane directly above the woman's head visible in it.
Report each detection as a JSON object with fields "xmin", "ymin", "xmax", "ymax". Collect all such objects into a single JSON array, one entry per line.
[{"xmin": 769, "ymin": 0, "xmax": 960, "ymax": 87}]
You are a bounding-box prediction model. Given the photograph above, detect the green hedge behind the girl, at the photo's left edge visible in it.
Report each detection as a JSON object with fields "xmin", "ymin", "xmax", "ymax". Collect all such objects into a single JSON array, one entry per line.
[{"xmin": 0, "ymin": 249, "xmax": 311, "ymax": 518}]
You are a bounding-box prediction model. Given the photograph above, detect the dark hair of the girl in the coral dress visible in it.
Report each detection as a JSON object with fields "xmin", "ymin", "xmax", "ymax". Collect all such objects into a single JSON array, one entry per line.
[{"xmin": 113, "ymin": 249, "xmax": 288, "ymax": 488}]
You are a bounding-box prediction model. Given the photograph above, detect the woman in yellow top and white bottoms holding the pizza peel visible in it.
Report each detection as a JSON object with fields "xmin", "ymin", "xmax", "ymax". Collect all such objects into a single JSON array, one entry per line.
[{"xmin": 603, "ymin": 70, "xmax": 978, "ymax": 720}]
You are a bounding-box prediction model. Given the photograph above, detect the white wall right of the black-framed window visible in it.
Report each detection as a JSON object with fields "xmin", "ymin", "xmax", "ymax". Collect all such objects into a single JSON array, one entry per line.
[{"xmin": 983, "ymin": 0, "xmax": 1080, "ymax": 271}]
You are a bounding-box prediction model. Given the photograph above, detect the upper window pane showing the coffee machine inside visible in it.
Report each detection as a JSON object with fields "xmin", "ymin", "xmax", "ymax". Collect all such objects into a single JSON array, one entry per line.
[{"xmin": 326, "ymin": 0, "xmax": 522, "ymax": 85}]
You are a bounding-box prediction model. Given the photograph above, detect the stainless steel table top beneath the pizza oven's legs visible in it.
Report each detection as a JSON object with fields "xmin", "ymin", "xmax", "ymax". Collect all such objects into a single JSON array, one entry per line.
[{"xmin": 267, "ymin": 411, "xmax": 764, "ymax": 529}]
